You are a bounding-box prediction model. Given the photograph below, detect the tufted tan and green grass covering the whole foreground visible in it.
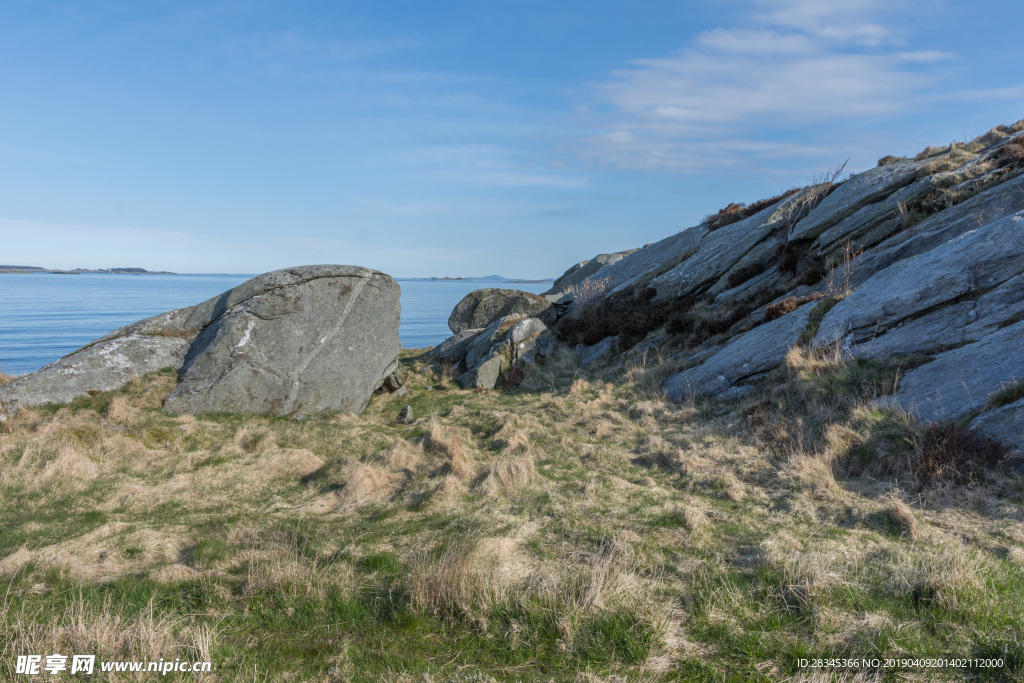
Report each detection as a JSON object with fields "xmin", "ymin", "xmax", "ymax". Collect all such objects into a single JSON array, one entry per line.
[{"xmin": 0, "ymin": 350, "xmax": 1024, "ymax": 681}]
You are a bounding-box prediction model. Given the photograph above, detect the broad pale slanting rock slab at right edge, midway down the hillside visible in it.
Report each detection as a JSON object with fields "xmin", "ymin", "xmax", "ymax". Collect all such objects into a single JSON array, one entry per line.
[{"xmin": 814, "ymin": 211, "xmax": 1024, "ymax": 345}]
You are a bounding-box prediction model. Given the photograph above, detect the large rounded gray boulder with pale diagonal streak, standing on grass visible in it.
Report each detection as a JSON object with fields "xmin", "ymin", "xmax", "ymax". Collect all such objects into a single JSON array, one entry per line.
[{"xmin": 164, "ymin": 265, "xmax": 400, "ymax": 416}]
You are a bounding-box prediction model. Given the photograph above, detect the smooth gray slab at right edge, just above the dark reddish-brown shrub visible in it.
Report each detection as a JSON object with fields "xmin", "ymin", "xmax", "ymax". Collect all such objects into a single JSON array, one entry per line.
[{"xmin": 879, "ymin": 322, "xmax": 1024, "ymax": 422}]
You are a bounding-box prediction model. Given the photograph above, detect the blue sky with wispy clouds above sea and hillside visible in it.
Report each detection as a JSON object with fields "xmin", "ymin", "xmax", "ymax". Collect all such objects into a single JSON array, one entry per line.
[{"xmin": 0, "ymin": 0, "xmax": 1024, "ymax": 278}]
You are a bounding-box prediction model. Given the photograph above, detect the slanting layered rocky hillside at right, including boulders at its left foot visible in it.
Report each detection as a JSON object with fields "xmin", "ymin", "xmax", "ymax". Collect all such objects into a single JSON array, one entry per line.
[{"xmin": 434, "ymin": 120, "xmax": 1024, "ymax": 456}]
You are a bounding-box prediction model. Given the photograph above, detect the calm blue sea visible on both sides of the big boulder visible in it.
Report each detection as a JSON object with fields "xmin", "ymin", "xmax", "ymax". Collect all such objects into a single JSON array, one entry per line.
[{"xmin": 0, "ymin": 273, "xmax": 551, "ymax": 375}]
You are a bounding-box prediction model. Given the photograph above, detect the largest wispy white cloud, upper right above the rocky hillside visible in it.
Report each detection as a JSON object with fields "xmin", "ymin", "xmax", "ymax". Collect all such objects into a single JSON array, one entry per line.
[{"xmin": 574, "ymin": 0, "xmax": 978, "ymax": 171}]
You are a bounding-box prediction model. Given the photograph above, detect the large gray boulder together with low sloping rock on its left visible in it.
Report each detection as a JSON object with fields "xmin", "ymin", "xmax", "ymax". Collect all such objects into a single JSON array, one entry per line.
[{"xmin": 0, "ymin": 265, "xmax": 402, "ymax": 416}]
